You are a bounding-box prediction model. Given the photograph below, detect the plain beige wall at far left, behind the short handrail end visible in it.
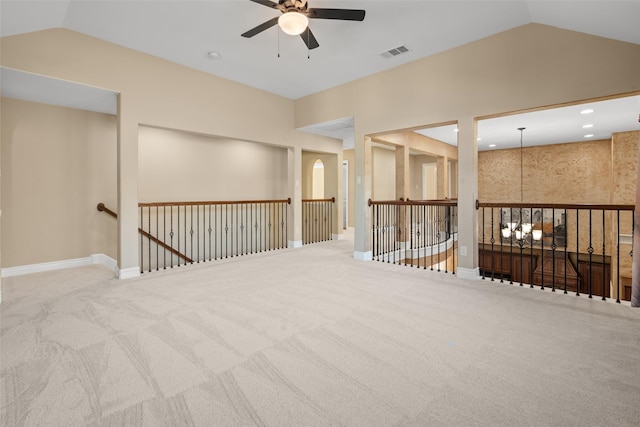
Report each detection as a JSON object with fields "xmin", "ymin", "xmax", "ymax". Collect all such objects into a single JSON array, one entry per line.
[{"xmin": 0, "ymin": 98, "xmax": 117, "ymax": 267}]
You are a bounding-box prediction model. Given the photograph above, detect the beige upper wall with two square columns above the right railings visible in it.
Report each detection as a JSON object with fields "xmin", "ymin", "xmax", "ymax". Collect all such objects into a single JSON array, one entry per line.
[{"xmin": 295, "ymin": 24, "xmax": 640, "ymax": 268}]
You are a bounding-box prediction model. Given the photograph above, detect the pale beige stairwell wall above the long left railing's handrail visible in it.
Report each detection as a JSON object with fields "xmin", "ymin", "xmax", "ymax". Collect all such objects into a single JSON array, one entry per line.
[{"xmin": 138, "ymin": 126, "xmax": 291, "ymax": 202}]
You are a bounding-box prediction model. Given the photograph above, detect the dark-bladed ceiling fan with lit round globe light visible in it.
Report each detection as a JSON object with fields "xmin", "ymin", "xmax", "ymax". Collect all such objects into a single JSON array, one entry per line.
[{"xmin": 242, "ymin": 0, "xmax": 365, "ymax": 49}]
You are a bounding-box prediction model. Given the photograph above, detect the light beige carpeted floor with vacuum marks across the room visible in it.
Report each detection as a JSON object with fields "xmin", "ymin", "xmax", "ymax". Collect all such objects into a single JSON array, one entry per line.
[{"xmin": 0, "ymin": 241, "xmax": 640, "ymax": 427}]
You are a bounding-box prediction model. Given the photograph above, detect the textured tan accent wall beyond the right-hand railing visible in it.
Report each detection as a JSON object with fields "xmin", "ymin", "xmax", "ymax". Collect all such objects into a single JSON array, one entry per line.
[{"xmin": 478, "ymin": 131, "xmax": 640, "ymax": 296}]
